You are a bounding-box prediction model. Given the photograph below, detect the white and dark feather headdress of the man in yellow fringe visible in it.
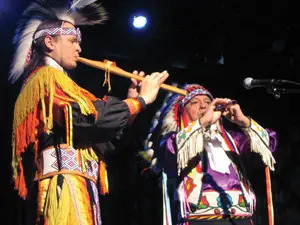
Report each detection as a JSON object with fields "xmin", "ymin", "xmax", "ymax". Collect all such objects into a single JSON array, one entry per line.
[{"xmin": 8, "ymin": 0, "xmax": 107, "ymax": 83}]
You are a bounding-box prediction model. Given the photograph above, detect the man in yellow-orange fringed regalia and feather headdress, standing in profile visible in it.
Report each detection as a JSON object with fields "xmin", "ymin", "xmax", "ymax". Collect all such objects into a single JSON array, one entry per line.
[{"xmin": 9, "ymin": 0, "xmax": 168, "ymax": 225}]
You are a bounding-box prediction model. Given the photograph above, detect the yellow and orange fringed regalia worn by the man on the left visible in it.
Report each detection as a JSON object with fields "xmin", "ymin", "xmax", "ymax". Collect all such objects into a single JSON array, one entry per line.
[{"xmin": 12, "ymin": 66, "xmax": 108, "ymax": 225}]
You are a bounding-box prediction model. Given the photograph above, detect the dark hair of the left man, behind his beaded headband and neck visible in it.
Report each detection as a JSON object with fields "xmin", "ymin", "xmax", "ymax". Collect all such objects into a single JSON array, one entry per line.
[{"xmin": 23, "ymin": 20, "xmax": 63, "ymax": 79}]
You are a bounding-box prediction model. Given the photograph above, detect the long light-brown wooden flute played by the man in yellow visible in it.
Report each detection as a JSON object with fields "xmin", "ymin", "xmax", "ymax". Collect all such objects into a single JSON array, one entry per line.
[{"xmin": 77, "ymin": 57, "xmax": 186, "ymax": 96}]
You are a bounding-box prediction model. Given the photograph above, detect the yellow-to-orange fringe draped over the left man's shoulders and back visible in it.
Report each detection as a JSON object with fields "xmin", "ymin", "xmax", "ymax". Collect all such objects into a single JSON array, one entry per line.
[{"xmin": 12, "ymin": 66, "xmax": 96, "ymax": 199}]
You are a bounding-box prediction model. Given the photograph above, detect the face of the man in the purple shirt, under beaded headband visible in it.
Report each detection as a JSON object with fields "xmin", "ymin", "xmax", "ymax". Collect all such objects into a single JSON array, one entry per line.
[{"xmin": 184, "ymin": 95, "xmax": 211, "ymax": 122}]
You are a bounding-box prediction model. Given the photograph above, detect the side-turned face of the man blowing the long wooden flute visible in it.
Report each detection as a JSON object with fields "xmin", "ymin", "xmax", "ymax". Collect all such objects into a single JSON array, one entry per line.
[{"xmin": 51, "ymin": 22, "xmax": 81, "ymax": 70}]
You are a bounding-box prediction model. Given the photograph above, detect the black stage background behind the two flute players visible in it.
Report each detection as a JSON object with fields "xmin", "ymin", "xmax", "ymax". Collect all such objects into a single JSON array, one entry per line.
[{"xmin": 0, "ymin": 0, "xmax": 300, "ymax": 225}]
